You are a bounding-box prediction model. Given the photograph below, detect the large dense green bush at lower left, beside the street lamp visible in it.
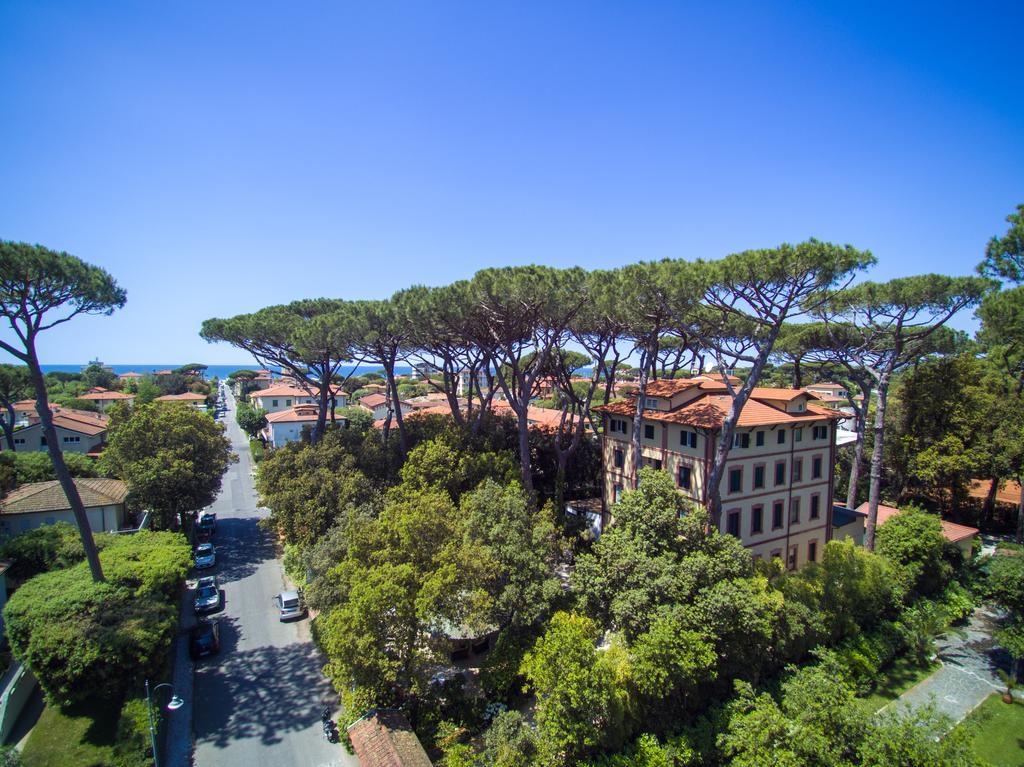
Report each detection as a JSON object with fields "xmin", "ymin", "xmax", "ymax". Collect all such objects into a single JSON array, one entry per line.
[{"xmin": 4, "ymin": 532, "xmax": 189, "ymax": 705}]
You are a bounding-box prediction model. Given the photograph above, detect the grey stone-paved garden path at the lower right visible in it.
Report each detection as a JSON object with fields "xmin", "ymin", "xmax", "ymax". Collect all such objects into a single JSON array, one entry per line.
[{"xmin": 884, "ymin": 607, "xmax": 1020, "ymax": 723}]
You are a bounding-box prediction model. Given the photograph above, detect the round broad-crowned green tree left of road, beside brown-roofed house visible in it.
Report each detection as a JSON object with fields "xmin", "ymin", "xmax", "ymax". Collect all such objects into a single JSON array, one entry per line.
[{"xmin": 101, "ymin": 402, "xmax": 236, "ymax": 529}]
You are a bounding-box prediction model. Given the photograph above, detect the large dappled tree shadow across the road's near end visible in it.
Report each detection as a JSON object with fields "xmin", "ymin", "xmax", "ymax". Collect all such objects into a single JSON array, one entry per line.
[{"xmin": 195, "ymin": 634, "xmax": 332, "ymax": 748}]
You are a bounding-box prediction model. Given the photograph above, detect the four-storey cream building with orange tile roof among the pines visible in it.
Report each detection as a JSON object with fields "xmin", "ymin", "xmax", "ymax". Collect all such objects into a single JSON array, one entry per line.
[{"xmin": 594, "ymin": 378, "xmax": 838, "ymax": 568}]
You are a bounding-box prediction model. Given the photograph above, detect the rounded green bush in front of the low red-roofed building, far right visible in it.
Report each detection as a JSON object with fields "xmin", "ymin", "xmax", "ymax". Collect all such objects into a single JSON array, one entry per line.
[{"xmin": 876, "ymin": 506, "xmax": 952, "ymax": 596}]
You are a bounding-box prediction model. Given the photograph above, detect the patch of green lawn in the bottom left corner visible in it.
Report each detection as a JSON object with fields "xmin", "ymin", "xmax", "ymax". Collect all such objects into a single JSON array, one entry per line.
[{"xmin": 22, "ymin": 706, "xmax": 119, "ymax": 767}]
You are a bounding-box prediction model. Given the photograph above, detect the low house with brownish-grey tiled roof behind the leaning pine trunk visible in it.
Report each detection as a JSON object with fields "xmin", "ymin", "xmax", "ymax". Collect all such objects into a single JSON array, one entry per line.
[{"xmin": 0, "ymin": 477, "xmax": 128, "ymax": 536}]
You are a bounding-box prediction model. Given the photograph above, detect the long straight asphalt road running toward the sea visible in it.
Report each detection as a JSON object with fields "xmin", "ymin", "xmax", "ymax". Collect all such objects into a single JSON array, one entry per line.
[{"xmin": 193, "ymin": 389, "xmax": 358, "ymax": 767}]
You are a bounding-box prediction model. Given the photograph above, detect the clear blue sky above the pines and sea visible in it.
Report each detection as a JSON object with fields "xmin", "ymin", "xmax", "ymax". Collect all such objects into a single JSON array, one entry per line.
[{"xmin": 0, "ymin": 0, "xmax": 1024, "ymax": 364}]
